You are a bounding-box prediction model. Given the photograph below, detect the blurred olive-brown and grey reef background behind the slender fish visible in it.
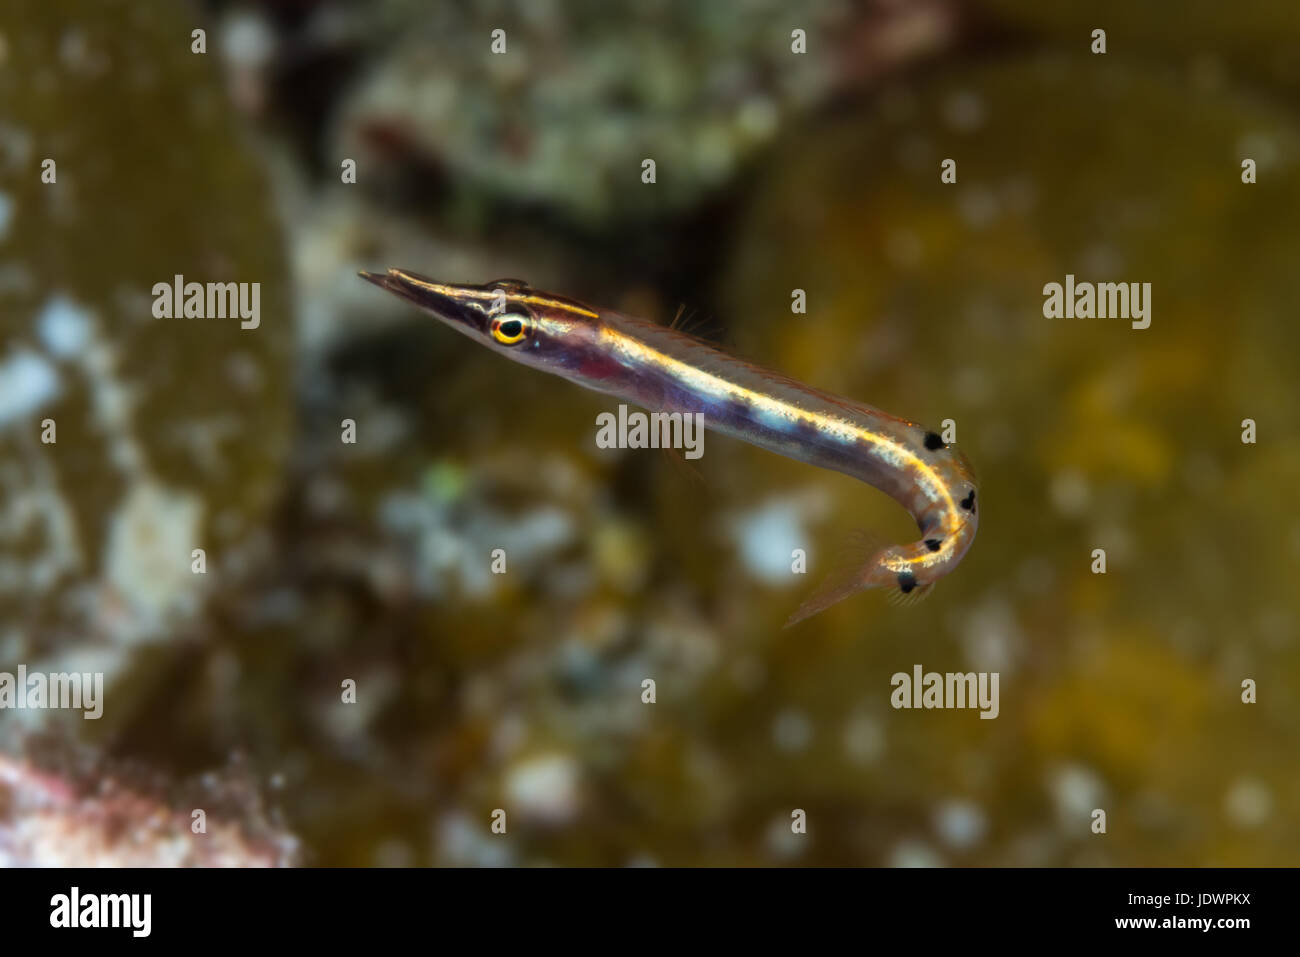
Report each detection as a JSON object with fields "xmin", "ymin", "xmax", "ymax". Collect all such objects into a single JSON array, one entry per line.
[{"xmin": 0, "ymin": 0, "xmax": 1300, "ymax": 866}]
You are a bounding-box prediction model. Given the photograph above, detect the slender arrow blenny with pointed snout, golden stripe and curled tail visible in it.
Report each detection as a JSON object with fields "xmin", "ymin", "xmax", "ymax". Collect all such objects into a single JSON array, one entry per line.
[{"xmin": 361, "ymin": 269, "xmax": 979, "ymax": 625}]
